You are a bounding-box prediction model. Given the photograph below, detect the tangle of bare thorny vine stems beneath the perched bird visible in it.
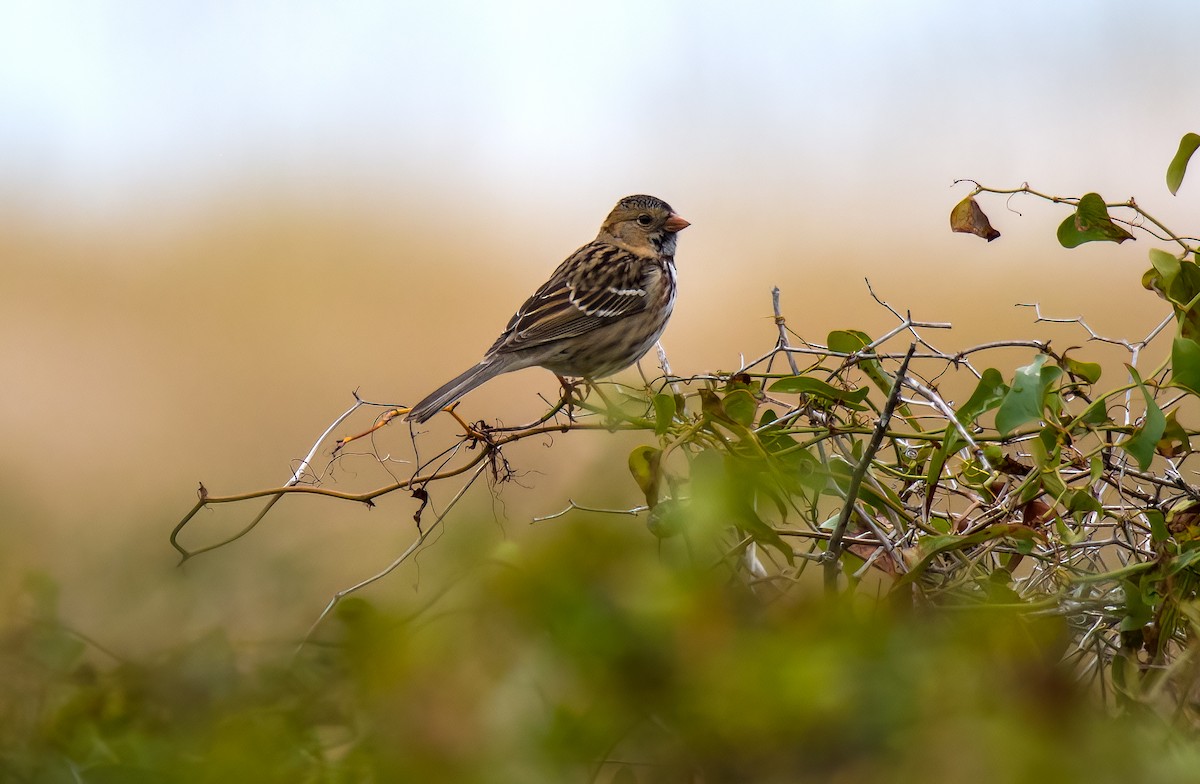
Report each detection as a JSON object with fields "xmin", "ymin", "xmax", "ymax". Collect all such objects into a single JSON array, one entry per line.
[{"xmin": 170, "ymin": 270, "xmax": 1200, "ymax": 686}]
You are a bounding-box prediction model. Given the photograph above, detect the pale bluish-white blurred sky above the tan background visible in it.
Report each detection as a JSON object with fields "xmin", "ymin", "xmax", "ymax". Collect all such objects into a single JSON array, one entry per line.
[{"xmin": 0, "ymin": 0, "xmax": 1200, "ymax": 223}]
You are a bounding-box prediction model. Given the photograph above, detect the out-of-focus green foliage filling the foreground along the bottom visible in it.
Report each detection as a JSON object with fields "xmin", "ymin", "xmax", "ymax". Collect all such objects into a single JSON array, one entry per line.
[{"xmin": 7, "ymin": 519, "xmax": 1200, "ymax": 783}]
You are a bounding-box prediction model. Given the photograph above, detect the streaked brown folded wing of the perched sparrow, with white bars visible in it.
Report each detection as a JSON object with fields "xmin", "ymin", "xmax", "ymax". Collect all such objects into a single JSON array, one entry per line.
[{"xmin": 488, "ymin": 243, "xmax": 647, "ymax": 353}]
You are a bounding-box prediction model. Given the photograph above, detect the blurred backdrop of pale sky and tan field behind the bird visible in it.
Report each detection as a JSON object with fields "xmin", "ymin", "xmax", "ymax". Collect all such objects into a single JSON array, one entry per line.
[{"xmin": 0, "ymin": 1, "xmax": 1200, "ymax": 650}]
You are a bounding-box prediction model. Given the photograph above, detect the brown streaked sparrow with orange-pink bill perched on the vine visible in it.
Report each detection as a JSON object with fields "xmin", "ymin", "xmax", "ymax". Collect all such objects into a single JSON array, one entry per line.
[{"xmin": 408, "ymin": 196, "xmax": 689, "ymax": 423}]
